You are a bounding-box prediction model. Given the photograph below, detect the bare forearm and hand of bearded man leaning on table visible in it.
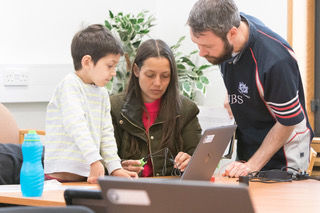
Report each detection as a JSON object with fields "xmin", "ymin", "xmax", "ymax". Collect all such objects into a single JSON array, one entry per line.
[{"xmin": 223, "ymin": 122, "xmax": 295, "ymax": 177}]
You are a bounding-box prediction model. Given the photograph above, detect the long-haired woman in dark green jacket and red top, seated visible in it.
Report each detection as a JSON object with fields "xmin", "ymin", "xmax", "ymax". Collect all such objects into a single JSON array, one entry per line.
[{"xmin": 110, "ymin": 39, "xmax": 201, "ymax": 177}]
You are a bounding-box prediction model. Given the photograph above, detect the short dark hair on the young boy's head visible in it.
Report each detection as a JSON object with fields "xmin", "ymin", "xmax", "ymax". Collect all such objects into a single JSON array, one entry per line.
[{"xmin": 71, "ymin": 24, "xmax": 124, "ymax": 70}]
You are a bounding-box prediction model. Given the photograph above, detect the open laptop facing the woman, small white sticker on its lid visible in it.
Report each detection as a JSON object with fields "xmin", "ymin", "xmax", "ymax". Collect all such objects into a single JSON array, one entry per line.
[{"xmin": 181, "ymin": 125, "xmax": 237, "ymax": 181}]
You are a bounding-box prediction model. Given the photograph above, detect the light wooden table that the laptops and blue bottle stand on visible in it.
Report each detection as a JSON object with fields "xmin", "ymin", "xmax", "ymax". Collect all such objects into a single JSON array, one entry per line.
[{"xmin": 0, "ymin": 178, "xmax": 320, "ymax": 213}]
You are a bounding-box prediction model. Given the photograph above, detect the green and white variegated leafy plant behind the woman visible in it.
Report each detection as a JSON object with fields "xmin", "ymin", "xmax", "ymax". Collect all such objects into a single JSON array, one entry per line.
[{"xmin": 105, "ymin": 10, "xmax": 212, "ymax": 100}]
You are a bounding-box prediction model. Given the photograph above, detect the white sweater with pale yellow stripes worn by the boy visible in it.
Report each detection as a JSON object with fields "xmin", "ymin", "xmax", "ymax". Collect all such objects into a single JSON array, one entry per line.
[{"xmin": 44, "ymin": 73, "xmax": 121, "ymax": 177}]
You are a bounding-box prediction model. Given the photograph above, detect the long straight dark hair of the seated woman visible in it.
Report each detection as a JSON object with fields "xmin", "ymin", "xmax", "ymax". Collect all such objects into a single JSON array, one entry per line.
[{"xmin": 126, "ymin": 39, "xmax": 182, "ymax": 154}]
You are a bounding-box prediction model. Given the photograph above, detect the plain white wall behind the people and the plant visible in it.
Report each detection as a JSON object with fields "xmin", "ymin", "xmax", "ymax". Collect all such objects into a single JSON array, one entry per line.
[{"xmin": 0, "ymin": 0, "xmax": 287, "ymax": 129}]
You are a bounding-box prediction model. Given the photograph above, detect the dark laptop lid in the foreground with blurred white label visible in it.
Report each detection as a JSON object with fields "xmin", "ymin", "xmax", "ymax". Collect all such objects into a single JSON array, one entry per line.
[{"xmin": 99, "ymin": 176, "xmax": 254, "ymax": 213}]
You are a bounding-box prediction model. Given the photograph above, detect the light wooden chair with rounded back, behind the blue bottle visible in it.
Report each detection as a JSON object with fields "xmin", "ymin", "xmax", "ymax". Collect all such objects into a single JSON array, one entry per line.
[{"xmin": 0, "ymin": 103, "xmax": 45, "ymax": 144}]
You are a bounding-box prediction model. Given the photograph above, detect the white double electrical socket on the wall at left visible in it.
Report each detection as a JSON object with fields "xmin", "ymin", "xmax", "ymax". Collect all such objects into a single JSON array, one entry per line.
[{"xmin": 3, "ymin": 68, "xmax": 29, "ymax": 86}]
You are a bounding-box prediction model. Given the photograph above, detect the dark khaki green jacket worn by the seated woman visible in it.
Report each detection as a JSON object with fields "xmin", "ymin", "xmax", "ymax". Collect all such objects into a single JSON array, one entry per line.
[{"xmin": 110, "ymin": 93, "xmax": 201, "ymax": 176}]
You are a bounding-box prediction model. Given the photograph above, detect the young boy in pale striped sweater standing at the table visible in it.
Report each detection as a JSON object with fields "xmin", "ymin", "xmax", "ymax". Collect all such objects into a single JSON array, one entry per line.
[{"xmin": 44, "ymin": 24, "xmax": 137, "ymax": 183}]
